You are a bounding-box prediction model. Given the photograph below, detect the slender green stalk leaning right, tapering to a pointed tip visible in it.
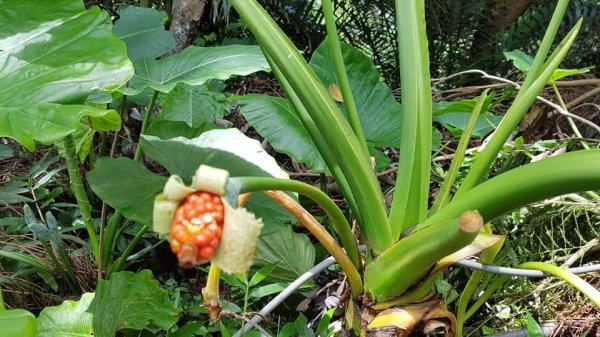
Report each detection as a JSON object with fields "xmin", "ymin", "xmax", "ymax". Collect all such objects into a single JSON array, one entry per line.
[{"xmin": 455, "ymin": 20, "xmax": 581, "ymax": 198}]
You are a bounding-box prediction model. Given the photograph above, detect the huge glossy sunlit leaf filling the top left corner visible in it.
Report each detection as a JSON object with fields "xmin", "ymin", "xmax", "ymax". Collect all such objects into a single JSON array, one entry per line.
[{"xmin": 0, "ymin": 0, "xmax": 133, "ymax": 150}]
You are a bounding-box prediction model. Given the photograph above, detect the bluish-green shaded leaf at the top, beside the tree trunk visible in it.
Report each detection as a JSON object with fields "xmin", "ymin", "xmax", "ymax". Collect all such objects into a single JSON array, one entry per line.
[{"xmin": 115, "ymin": 6, "xmax": 175, "ymax": 60}]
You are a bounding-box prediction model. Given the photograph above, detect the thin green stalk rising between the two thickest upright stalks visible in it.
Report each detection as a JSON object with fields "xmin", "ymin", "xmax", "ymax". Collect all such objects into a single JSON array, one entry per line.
[{"xmin": 322, "ymin": 0, "xmax": 369, "ymax": 156}]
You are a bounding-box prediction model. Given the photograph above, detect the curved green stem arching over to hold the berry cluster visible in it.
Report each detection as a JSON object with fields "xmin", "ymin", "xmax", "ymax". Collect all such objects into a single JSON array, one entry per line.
[{"xmin": 229, "ymin": 177, "xmax": 360, "ymax": 268}]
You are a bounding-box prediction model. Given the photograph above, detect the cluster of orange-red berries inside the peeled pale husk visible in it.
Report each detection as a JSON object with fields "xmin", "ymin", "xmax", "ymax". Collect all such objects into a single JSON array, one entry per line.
[{"xmin": 171, "ymin": 192, "xmax": 225, "ymax": 268}]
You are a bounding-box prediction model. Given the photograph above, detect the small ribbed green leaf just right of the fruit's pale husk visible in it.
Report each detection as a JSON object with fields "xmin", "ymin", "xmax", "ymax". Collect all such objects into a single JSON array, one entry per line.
[{"xmin": 255, "ymin": 226, "xmax": 315, "ymax": 282}]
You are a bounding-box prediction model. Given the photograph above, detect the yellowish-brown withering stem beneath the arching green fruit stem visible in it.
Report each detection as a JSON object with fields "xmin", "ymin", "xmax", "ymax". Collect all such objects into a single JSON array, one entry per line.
[{"xmin": 265, "ymin": 191, "xmax": 363, "ymax": 297}]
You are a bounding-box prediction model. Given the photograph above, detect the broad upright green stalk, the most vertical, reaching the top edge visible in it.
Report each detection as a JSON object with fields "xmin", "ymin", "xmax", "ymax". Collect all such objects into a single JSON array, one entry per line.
[{"xmin": 389, "ymin": 0, "xmax": 432, "ymax": 238}]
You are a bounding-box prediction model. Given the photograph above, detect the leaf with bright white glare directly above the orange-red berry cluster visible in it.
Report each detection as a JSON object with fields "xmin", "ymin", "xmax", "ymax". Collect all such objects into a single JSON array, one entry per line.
[{"xmin": 140, "ymin": 129, "xmax": 288, "ymax": 179}]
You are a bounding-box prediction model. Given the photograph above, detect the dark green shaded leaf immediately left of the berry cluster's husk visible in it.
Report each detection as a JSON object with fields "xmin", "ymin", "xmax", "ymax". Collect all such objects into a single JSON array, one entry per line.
[{"xmin": 87, "ymin": 158, "xmax": 167, "ymax": 225}]
